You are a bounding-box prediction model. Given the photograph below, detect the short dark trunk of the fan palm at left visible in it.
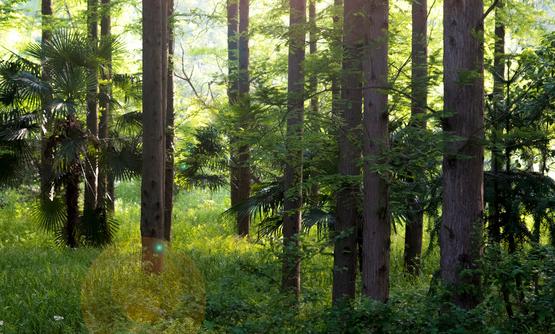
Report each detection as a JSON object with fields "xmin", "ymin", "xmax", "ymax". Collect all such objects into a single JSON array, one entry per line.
[{"xmin": 65, "ymin": 166, "xmax": 79, "ymax": 248}]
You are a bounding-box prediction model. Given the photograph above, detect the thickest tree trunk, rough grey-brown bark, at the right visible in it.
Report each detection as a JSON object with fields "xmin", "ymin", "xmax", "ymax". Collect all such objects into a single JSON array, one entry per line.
[{"xmin": 440, "ymin": 0, "xmax": 484, "ymax": 308}]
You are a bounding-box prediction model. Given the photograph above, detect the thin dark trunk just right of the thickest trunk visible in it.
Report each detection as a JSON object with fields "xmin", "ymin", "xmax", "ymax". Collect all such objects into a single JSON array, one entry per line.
[{"xmin": 489, "ymin": 0, "xmax": 505, "ymax": 242}]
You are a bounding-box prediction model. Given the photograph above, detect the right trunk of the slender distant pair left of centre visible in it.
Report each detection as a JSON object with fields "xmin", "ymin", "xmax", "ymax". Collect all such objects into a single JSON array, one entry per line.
[{"xmin": 235, "ymin": 0, "xmax": 251, "ymax": 236}]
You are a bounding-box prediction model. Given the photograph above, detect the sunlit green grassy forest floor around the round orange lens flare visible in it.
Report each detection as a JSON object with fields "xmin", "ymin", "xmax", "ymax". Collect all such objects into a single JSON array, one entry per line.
[{"xmin": 0, "ymin": 182, "xmax": 438, "ymax": 333}]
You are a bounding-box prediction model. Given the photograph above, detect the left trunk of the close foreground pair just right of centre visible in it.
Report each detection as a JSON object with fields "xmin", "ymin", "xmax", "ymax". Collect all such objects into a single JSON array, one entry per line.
[{"xmin": 333, "ymin": 0, "xmax": 364, "ymax": 304}]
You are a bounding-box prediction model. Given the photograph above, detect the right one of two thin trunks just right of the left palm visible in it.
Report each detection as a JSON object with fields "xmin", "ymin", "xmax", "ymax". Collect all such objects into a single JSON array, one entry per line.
[{"xmin": 97, "ymin": 0, "xmax": 113, "ymax": 210}]
